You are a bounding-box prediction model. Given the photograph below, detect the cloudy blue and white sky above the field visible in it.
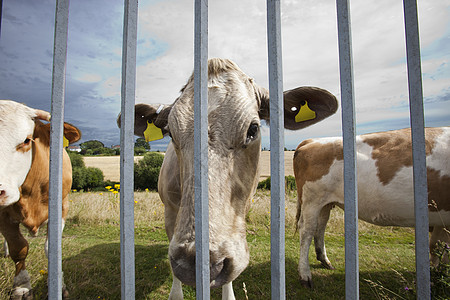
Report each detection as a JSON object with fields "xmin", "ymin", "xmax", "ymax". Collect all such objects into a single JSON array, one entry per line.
[{"xmin": 0, "ymin": 0, "xmax": 450, "ymax": 150}]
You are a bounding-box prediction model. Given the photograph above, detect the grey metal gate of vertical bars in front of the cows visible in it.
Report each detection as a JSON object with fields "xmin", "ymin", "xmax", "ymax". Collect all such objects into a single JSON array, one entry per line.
[{"xmin": 0, "ymin": 0, "xmax": 430, "ymax": 300}]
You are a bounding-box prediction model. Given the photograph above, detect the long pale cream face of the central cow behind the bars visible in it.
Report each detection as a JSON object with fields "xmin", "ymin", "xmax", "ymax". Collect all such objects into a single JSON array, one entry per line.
[{"xmin": 167, "ymin": 62, "xmax": 261, "ymax": 286}]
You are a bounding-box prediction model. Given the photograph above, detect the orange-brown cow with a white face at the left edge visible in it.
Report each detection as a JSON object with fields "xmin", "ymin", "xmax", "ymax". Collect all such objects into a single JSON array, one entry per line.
[{"xmin": 0, "ymin": 100, "xmax": 81, "ymax": 299}]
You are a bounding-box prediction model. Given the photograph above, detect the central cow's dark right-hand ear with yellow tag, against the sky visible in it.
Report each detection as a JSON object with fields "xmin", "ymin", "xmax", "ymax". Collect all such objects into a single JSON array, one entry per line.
[{"xmin": 256, "ymin": 87, "xmax": 338, "ymax": 130}]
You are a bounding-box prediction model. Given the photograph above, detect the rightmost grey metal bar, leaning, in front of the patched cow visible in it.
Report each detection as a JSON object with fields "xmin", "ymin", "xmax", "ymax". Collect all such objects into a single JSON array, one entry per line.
[{"xmin": 403, "ymin": 0, "xmax": 431, "ymax": 299}]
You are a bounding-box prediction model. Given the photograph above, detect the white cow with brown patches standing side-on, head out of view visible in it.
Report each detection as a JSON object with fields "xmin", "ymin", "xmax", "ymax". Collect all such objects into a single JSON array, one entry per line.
[{"xmin": 294, "ymin": 127, "xmax": 450, "ymax": 287}]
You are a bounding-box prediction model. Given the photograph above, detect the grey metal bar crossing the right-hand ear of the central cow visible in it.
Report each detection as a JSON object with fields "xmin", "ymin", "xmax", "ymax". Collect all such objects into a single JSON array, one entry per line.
[{"xmin": 267, "ymin": 0, "xmax": 286, "ymax": 299}]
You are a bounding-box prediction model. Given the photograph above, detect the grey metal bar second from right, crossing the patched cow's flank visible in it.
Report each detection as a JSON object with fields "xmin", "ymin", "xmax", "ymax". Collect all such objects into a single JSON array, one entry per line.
[{"xmin": 336, "ymin": 0, "xmax": 359, "ymax": 299}]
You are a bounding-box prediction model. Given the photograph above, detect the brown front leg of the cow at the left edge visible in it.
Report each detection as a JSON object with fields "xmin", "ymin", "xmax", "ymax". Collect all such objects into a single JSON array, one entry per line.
[{"xmin": 0, "ymin": 216, "xmax": 33, "ymax": 300}]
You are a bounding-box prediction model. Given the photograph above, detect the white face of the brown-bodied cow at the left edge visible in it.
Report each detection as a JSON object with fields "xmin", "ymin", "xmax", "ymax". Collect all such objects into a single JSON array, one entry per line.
[{"xmin": 0, "ymin": 100, "xmax": 50, "ymax": 208}]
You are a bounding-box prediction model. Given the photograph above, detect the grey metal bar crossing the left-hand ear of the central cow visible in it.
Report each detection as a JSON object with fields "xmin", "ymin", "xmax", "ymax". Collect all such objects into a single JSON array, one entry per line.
[{"xmin": 120, "ymin": 0, "xmax": 138, "ymax": 300}]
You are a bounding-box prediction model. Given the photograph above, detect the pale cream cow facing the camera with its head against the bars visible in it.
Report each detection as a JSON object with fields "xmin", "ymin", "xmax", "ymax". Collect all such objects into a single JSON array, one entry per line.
[{"xmin": 123, "ymin": 59, "xmax": 337, "ymax": 299}]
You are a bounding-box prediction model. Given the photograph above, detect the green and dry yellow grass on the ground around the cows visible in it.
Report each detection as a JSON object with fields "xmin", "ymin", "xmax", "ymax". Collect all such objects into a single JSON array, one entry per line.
[{"xmin": 0, "ymin": 191, "xmax": 415, "ymax": 299}]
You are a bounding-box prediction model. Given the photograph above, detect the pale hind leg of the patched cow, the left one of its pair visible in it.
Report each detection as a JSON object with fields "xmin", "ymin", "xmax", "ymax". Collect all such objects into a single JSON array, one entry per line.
[{"xmin": 298, "ymin": 203, "xmax": 321, "ymax": 288}]
